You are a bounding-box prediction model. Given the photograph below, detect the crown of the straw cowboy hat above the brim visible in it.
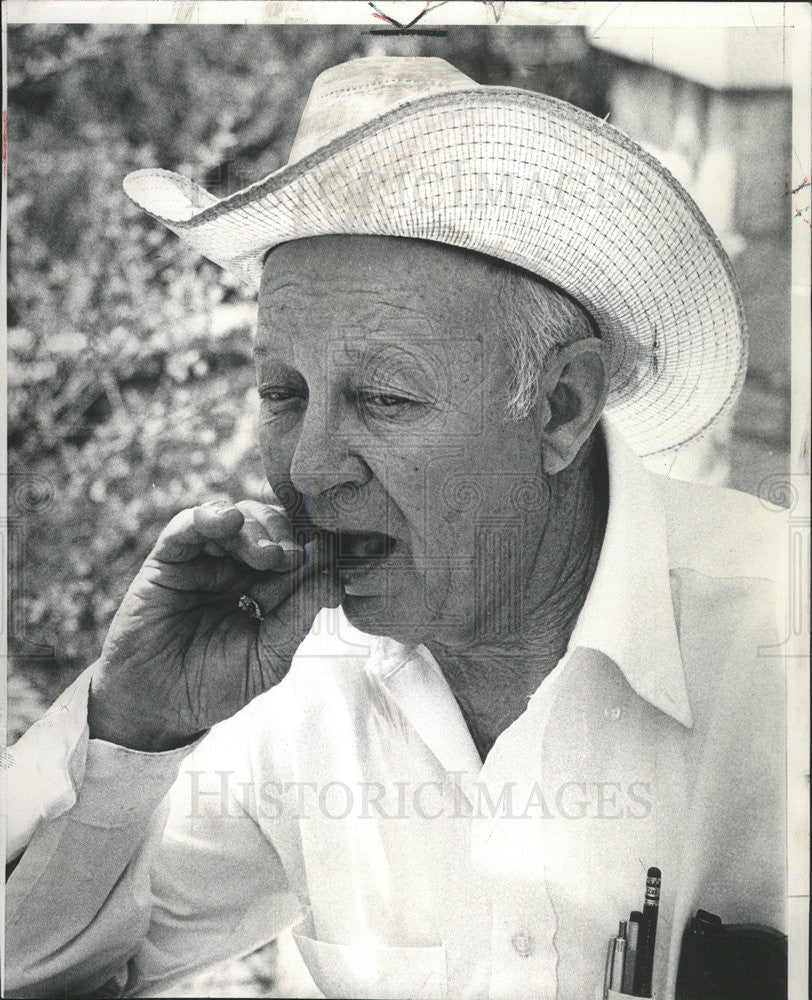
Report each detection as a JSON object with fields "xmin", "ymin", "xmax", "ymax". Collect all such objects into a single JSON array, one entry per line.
[{"xmin": 288, "ymin": 56, "xmax": 479, "ymax": 164}]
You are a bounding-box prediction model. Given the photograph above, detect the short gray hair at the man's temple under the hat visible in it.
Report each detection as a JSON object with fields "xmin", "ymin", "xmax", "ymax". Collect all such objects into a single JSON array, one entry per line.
[{"xmin": 491, "ymin": 261, "xmax": 599, "ymax": 420}]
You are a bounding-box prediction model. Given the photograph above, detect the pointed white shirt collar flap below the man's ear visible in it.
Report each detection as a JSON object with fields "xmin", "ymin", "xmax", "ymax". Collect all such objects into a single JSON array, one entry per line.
[{"xmin": 570, "ymin": 416, "xmax": 693, "ymax": 728}]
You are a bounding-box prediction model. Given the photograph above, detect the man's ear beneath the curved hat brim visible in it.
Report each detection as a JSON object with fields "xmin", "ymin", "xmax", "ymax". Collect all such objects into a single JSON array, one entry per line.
[{"xmin": 539, "ymin": 337, "xmax": 609, "ymax": 476}]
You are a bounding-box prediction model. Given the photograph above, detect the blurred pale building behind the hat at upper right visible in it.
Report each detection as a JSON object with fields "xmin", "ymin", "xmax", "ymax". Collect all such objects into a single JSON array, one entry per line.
[{"xmin": 589, "ymin": 27, "xmax": 792, "ymax": 257}]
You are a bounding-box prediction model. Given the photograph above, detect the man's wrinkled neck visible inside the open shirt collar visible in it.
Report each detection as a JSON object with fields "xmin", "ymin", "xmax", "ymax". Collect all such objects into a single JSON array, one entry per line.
[{"xmin": 426, "ymin": 439, "xmax": 608, "ymax": 759}]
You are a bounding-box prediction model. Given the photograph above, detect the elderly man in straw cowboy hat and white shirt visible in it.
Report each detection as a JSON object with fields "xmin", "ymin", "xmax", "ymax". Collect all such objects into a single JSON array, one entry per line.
[{"xmin": 6, "ymin": 58, "xmax": 784, "ymax": 1000}]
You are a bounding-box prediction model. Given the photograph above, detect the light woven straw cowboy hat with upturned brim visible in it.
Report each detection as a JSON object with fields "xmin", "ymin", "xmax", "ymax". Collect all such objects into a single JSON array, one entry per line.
[{"xmin": 124, "ymin": 57, "xmax": 747, "ymax": 455}]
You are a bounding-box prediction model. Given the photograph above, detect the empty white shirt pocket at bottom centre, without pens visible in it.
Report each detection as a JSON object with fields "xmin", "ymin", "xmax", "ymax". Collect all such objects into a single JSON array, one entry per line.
[{"xmin": 293, "ymin": 920, "xmax": 447, "ymax": 1000}]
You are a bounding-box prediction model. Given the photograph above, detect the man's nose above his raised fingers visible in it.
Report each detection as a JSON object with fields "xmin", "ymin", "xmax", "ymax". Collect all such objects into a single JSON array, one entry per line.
[{"xmin": 290, "ymin": 406, "xmax": 371, "ymax": 497}]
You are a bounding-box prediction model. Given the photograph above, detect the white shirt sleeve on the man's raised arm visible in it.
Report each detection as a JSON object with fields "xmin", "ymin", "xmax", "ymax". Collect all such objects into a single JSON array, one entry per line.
[{"xmin": 5, "ymin": 668, "xmax": 298, "ymax": 998}]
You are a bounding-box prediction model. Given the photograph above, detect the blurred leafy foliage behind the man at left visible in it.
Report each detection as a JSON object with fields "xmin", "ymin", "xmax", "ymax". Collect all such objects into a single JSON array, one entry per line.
[{"xmin": 8, "ymin": 24, "xmax": 605, "ymax": 740}]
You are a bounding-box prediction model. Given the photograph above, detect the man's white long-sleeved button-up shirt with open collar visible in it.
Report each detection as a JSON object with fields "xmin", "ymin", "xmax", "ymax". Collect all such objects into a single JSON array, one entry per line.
[{"xmin": 6, "ymin": 422, "xmax": 786, "ymax": 1000}]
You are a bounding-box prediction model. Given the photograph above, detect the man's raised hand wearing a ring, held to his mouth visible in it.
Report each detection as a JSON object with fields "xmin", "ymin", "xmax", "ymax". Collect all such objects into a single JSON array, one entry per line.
[{"xmin": 88, "ymin": 500, "xmax": 342, "ymax": 751}]
